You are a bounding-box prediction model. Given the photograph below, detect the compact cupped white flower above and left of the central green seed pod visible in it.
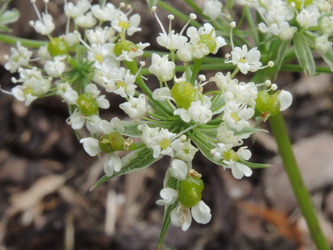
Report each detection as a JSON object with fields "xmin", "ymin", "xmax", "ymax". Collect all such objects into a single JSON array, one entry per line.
[{"xmin": 148, "ymin": 53, "xmax": 176, "ymax": 82}]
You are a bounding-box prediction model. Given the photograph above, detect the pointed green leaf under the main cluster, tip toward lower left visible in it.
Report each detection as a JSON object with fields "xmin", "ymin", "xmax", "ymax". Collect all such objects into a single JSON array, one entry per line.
[{"xmin": 90, "ymin": 147, "xmax": 162, "ymax": 191}]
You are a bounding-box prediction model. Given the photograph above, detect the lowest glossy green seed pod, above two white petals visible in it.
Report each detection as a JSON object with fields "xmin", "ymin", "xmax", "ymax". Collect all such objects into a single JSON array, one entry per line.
[{"xmin": 178, "ymin": 176, "xmax": 204, "ymax": 207}]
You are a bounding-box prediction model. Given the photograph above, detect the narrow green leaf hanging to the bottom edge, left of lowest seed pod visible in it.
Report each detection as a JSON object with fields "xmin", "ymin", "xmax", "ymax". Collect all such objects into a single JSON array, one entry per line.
[{"xmin": 157, "ymin": 176, "xmax": 181, "ymax": 249}]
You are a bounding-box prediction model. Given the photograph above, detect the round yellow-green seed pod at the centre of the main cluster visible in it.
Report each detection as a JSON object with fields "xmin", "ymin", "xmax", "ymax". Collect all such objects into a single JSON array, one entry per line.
[{"xmin": 171, "ymin": 82, "xmax": 196, "ymax": 109}]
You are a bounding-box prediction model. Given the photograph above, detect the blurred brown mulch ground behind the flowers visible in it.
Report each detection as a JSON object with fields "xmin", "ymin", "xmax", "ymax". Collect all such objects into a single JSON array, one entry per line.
[{"xmin": 0, "ymin": 0, "xmax": 333, "ymax": 250}]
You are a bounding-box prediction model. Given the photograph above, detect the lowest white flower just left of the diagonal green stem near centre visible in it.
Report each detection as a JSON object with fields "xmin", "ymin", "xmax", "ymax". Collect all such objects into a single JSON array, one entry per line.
[{"xmin": 119, "ymin": 94, "xmax": 147, "ymax": 119}]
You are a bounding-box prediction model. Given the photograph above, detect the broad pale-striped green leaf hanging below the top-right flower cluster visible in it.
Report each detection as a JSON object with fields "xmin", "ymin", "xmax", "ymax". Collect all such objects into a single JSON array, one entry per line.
[{"xmin": 294, "ymin": 34, "xmax": 316, "ymax": 75}]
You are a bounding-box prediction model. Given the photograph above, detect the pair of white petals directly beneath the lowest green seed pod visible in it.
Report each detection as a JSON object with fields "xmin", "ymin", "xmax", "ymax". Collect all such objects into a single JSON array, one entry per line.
[{"xmin": 170, "ymin": 201, "xmax": 212, "ymax": 231}]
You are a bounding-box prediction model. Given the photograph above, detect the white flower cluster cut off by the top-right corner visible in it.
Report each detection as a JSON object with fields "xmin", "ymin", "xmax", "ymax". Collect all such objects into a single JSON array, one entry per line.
[{"xmin": 238, "ymin": 0, "xmax": 333, "ymax": 54}]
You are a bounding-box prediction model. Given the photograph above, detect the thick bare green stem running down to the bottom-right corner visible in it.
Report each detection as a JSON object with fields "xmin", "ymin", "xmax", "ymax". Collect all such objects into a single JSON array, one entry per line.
[{"xmin": 269, "ymin": 113, "xmax": 330, "ymax": 250}]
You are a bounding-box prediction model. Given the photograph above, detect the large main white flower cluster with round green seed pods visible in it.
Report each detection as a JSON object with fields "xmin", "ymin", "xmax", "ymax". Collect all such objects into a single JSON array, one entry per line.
[{"xmin": 5, "ymin": 0, "xmax": 294, "ymax": 237}]
